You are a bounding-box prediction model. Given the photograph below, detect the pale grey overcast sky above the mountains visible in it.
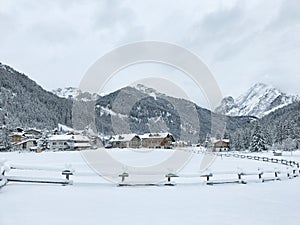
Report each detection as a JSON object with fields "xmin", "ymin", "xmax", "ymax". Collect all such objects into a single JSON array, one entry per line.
[{"xmin": 0, "ymin": 0, "xmax": 300, "ymax": 106}]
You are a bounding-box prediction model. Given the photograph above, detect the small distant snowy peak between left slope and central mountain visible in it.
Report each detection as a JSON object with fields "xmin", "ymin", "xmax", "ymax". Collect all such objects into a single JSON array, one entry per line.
[{"xmin": 52, "ymin": 87, "xmax": 99, "ymax": 101}]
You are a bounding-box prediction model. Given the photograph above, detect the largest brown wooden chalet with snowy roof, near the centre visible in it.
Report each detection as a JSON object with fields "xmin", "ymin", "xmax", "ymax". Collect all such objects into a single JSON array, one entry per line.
[{"xmin": 140, "ymin": 133, "xmax": 175, "ymax": 148}]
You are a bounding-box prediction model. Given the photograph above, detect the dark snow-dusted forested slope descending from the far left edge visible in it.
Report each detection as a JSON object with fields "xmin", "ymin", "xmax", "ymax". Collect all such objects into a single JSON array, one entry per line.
[{"xmin": 0, "ymin": 63, "xmax": 72, "ymax": 129}]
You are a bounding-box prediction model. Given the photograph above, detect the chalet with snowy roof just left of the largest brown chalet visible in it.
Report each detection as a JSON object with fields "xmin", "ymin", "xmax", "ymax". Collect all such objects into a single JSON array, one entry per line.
[{"xmin": 109, "ymin": 134, "xmax": 141, "ymax": 148}]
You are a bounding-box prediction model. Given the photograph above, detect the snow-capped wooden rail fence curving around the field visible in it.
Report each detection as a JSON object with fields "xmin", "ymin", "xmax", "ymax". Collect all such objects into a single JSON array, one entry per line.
[{"xmin": 0, "ymin": 150, "xmax": 300, "ymax": 187}]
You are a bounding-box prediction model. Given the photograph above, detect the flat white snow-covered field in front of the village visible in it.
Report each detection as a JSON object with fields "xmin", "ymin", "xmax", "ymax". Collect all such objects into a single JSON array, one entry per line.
[{"xmin": 0, "ymin": 149, "xmax": 300, "ymax": 225}]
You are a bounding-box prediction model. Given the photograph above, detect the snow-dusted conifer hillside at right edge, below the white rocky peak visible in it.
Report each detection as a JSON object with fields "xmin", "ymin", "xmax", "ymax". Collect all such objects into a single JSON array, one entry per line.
[{"xmin": 230, "ymin": 102, "xmax": 300, "ymax": 150}]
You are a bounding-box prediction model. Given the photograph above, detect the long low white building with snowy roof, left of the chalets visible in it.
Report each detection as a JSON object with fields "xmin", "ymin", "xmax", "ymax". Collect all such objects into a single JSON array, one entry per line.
[{"xmin": 48, "ymin": 134, "xmax": 92, "ymax": 151}]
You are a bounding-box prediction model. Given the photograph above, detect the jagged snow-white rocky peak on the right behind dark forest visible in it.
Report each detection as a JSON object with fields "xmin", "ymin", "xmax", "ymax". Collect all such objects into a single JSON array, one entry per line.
[{"xmin": 215, "ymin": 83, "xmax": 299, "ymax": 118}]
